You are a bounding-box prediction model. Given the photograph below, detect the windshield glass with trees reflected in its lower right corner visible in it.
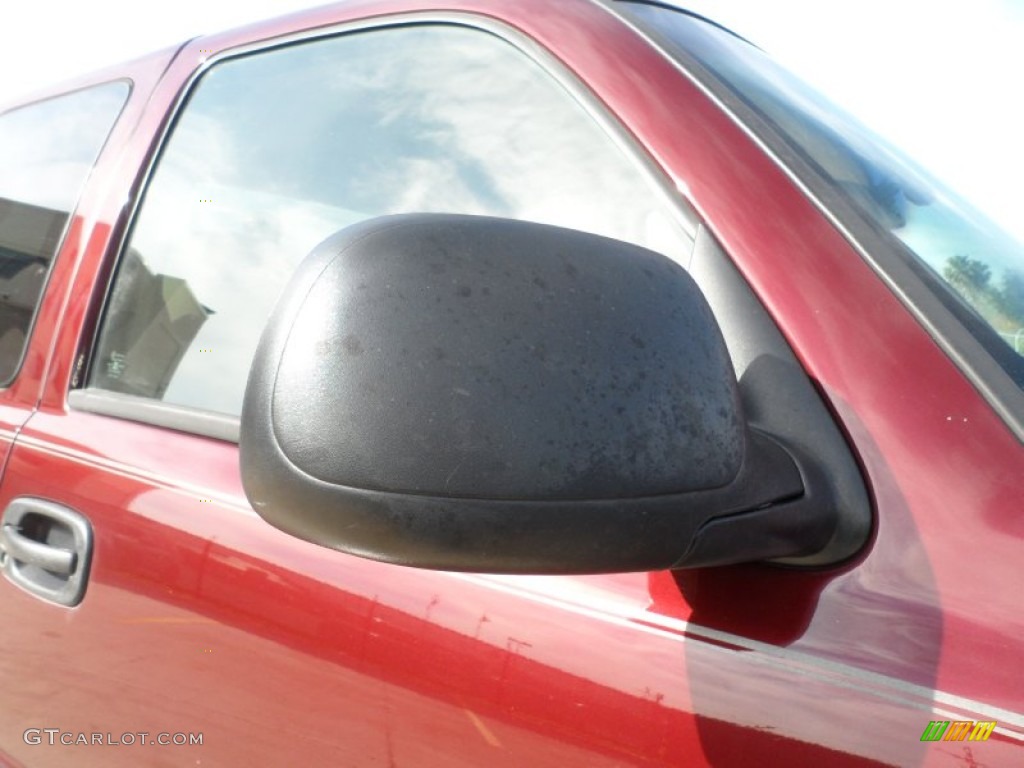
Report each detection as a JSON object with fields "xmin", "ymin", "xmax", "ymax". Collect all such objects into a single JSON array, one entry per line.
[{"xmin": 622, "ymin": 3, "xmax": 1024, "ymax": 389}]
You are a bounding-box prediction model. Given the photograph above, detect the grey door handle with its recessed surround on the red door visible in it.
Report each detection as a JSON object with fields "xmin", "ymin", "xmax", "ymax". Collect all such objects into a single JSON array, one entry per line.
[{"xmin": 0, "ymin": 497, "xmax": 92, "ymax": 606}]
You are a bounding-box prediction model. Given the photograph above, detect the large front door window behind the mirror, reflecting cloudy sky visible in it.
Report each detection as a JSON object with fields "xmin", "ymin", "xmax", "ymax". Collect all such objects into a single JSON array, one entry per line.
[{"xmin": 89, "ymin": 25, "xmax": 690, "ymax": 416}]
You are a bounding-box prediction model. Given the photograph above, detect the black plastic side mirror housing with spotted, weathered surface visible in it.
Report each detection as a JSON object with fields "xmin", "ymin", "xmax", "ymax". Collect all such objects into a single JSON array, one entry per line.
[{"xmin": 241, "ymin": 214, "xmax": 833, "ymax": 573}]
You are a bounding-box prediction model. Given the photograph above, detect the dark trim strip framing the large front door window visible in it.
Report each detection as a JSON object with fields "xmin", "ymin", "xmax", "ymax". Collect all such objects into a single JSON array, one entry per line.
[{"xmin": 68, "ymin": 11, "xmax": 699, "ymax": 443}]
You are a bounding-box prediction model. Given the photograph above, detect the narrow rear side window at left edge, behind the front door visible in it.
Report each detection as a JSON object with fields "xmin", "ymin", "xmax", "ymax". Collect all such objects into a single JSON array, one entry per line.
[{"xmin": 0, "ymin": 82, "xmax": 129, "ymax": 385}]
